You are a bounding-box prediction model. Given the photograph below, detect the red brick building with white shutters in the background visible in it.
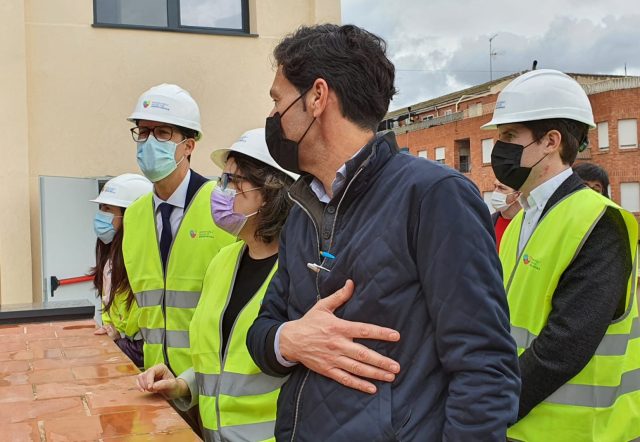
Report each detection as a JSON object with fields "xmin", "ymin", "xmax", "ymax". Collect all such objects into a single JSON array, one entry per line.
[{"xmin": 379, "ymin": 74, "xmax": 640, "ymax": 216}]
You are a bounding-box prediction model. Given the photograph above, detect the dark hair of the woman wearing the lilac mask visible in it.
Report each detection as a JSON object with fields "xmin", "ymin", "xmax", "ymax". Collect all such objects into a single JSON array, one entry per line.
[{"xmin": 229, "ymin": 152, "xmax": 293, "ymax": 243}]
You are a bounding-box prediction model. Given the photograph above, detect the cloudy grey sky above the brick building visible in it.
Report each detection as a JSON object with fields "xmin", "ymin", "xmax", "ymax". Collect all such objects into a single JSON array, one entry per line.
[{"xmin": 342, "ymin": 0, "xmax": 640, "ymax": 110}]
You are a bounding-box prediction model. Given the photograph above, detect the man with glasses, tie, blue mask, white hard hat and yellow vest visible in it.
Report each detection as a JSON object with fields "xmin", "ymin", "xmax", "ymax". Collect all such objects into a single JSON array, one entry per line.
[{"xmin": 123, "ymin": 84, "xmax": 234, "ymax": 374}]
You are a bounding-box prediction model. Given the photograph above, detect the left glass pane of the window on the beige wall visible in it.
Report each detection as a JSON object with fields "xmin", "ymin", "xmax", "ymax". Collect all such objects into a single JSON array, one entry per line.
[{"xmin": 96, "ymin": 0, "xmax": 167, "ymax": 27}]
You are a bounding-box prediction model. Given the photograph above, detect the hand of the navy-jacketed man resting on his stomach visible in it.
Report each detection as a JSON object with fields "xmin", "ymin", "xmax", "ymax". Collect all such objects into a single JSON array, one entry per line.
[{"xmin": 279, "ymin": 280, "xmax": 400, "ymax": 394}]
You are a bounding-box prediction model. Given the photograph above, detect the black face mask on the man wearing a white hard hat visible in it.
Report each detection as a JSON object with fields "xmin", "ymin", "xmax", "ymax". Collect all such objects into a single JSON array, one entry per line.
[{"xmin": 491, "ymin": 140, "xmax": 547, "ymax": 190}]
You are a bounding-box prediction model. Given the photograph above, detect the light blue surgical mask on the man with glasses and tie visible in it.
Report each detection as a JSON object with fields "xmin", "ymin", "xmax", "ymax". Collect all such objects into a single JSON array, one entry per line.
[{"xmin": 137, "ymin": 135, "xmax": 188, "ymax": 183}]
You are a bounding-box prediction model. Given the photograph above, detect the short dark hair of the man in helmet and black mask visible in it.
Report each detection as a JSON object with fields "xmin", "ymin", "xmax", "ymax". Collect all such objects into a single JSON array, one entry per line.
[{"xmin": 521, "ymin": 118, "xmax": 589, "ymax": 166}]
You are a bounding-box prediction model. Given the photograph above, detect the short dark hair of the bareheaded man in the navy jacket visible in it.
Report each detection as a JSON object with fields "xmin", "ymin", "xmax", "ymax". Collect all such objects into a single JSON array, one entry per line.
[{"xmin": 273, "ymin": 24, "xmax": 396, "ymax": 131}]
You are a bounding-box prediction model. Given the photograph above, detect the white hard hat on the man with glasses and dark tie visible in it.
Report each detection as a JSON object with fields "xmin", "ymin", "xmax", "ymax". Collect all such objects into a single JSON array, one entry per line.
[{"xmin": 127, "ymin": 83, "xmax": 201, "ymax": 136}]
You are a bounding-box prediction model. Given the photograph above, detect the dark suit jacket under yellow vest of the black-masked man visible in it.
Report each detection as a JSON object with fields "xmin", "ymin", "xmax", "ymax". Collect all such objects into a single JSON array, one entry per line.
[{"xmin": 518, "ymin": 173, "xmax": 632, "ymax": 419}]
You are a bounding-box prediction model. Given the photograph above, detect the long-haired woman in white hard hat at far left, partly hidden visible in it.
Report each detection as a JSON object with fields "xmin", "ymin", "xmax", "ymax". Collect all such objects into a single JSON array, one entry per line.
[{"xmin": 91, "ymin": 173, "xmax": 153, "ymax": 367}]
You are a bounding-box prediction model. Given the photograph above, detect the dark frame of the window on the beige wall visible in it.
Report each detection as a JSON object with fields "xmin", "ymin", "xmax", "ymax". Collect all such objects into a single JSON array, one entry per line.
[{"xmin": 92, "ymin": 0, "xmax": 252, "ymax": 37}]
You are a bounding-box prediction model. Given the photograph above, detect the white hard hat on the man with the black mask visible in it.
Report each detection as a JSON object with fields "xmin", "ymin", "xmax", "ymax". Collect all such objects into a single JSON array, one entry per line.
[{"xmin": 482, "ymin": 69, "xmax": 596, "ymax": 129}]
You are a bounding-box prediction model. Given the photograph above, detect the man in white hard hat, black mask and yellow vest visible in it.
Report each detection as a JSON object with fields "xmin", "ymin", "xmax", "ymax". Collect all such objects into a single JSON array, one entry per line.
[{"xmin": 483, "ymin": 69, "xmax": 640, "ymax": 441}]
